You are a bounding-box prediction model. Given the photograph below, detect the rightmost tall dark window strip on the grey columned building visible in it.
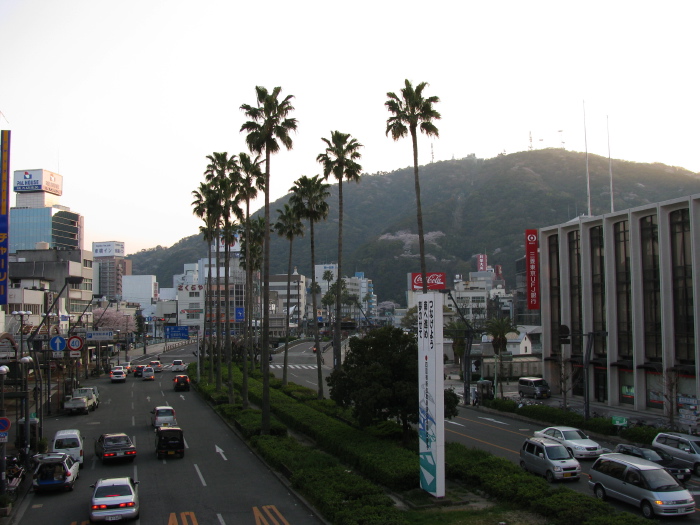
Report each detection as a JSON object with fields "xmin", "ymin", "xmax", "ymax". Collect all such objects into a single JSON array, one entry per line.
[{"xmin": 670, "ymin": 208, "xmax": 695, "ymax": 364}]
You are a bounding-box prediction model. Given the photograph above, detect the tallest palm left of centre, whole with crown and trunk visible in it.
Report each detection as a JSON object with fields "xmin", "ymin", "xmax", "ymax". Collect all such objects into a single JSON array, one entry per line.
[{"xmin": 241, "ymin": 86, "xmax": 297, "ymax": 435}]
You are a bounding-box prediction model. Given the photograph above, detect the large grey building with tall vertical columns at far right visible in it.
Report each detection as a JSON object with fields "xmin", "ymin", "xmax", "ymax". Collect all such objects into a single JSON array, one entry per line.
[{"xmin": 539, "ymin": 194, "xmax": 700, "ymax": 417}]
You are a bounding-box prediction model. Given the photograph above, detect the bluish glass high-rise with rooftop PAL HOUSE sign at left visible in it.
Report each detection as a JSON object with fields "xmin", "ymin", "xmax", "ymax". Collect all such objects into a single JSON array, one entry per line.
[{"xmin": 9, "ymin": 169, "xmax": 84, "ymax": 253}]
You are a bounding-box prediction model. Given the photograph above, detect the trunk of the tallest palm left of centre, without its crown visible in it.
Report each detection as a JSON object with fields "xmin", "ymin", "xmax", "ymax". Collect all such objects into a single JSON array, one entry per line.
[{"xmin": 260, "ymin": 146, "xmax": 270, "ymax": 435}]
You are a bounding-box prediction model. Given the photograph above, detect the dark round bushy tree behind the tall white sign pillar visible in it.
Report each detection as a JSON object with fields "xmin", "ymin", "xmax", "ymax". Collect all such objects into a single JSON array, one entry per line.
[{"xmin": 328, "ymin": 327, "xmax": 459, "ymax": 441}]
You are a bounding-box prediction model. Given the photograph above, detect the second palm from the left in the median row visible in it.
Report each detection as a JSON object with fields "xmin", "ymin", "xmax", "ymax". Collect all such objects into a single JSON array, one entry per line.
[{"xmin": 204, "ymin": 152, "xmax": 238, "ymax": 392}]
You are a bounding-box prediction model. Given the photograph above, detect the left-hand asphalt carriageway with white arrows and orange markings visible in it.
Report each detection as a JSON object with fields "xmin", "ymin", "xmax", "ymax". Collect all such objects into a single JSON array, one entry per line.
[{"xmin": 15, "ymin": 346, "xmax": 323, "ymax": 525}]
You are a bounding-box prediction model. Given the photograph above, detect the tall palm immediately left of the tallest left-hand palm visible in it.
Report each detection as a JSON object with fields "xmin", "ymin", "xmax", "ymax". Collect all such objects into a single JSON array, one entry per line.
[{"xmin": 238, "ymin": 152, "xmax": 265, "ymax": 409}]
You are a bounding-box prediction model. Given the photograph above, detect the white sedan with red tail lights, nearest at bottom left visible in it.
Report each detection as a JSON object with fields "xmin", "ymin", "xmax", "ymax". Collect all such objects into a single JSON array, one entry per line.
[{"xmin": 90, "ymin": 477, "xmax": 139, "ymax": 523}]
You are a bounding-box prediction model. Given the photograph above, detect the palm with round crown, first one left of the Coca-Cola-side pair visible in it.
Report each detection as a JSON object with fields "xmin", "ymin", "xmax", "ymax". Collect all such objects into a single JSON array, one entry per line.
[{"xmin": 289, "ymin": 175, "xmax": 330, "ymax": 399}]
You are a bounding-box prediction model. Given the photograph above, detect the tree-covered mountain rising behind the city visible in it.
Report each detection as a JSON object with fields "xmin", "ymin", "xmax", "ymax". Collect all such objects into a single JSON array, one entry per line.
[{"xmin": 128, "ymin": 149, "xmax": 700, "ymax": 304}]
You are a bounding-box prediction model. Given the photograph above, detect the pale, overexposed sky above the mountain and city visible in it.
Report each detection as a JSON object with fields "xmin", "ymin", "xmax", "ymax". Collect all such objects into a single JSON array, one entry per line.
[{"xmin": 0, "ymin": 0, "xmax": 700, "ymax": 254}]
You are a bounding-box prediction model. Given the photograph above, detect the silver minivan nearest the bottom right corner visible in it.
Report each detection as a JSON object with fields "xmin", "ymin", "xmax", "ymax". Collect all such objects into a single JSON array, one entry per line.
[{"xmin": 588, "ymin": 454, "xmax": 695, "ymax": 518}]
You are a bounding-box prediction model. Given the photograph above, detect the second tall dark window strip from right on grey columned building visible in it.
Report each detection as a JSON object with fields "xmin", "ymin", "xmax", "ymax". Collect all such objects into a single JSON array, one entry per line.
[{"xmin": 640, "ymin": 215, "xmax": 661, "ymax": 362}]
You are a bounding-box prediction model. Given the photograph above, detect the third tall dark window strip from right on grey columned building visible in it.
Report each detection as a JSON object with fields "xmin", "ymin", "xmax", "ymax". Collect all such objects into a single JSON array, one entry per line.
[{"xmin": 613, "ymin": 221, "xmax": 632, "ymax": 358}]
